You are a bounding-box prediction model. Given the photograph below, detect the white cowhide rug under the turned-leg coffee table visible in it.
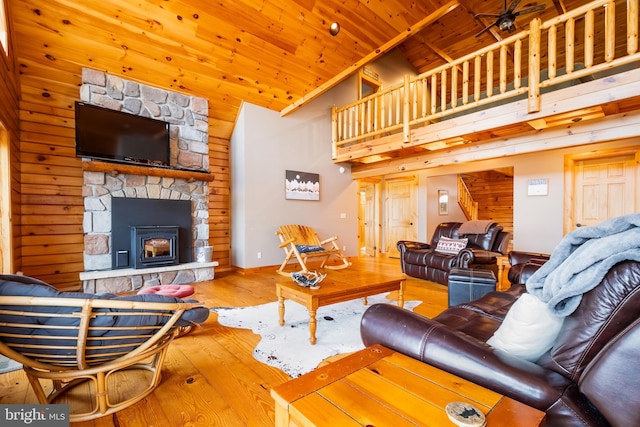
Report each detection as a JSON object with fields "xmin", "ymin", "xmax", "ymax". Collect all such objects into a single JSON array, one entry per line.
[{"xmin": 211, "ymin": 294, "xmax": 422, "ymax": 378}]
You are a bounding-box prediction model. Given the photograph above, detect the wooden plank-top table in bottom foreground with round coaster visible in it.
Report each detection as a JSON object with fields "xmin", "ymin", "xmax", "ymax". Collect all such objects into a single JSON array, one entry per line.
[{"xmin": 271, "ymin": 346, "xmax": 545, "ymax": 427}]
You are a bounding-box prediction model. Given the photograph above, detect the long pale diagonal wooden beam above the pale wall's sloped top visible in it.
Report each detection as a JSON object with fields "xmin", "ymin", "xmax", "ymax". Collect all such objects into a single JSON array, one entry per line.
[{"xmin": 280, "ymin": 0, "xmax": 460, "ymax": 117}]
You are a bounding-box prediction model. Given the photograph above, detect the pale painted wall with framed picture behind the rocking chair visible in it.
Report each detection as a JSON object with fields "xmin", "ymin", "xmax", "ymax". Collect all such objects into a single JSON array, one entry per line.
[{"xmin": 231, "ymin": 80, "xmax": 358, "ymax": 268}]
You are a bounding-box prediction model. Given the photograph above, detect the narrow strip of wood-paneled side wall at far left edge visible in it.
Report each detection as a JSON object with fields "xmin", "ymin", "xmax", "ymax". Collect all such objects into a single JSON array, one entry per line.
[{"xmin": 0, "ymin": 0, "xmax": 21, "ymax": 273}]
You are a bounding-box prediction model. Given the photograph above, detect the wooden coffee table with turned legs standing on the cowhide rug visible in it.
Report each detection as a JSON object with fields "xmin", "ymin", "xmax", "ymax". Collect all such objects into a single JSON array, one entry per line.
[{"xmin": 276, "ymin": 270, "xmax": 405, "ymax": 345}]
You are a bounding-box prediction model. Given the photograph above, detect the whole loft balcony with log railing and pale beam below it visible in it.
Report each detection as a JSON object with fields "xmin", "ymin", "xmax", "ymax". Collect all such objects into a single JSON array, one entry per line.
[{"xmin": 332, "ymin": 0, "xmax": 640, "ymax": 177}]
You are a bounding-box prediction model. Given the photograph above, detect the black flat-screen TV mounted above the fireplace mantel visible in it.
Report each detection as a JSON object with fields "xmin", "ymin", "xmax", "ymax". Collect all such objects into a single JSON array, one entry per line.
[{"xmin": 76, "ymin": 102, "xmax": 170, "ymax": 167}]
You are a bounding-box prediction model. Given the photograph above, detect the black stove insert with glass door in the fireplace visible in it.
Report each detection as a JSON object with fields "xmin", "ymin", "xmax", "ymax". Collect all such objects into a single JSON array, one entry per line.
[{"xmin": 131, "ymin": 225, "xmax": 180, "ymax": 268}]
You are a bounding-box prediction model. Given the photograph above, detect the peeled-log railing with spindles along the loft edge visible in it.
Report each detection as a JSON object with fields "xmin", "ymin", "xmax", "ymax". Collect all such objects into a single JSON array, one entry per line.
[{"xmin": 332, "ymin": 0, "xmax": 640, "ymax": 161}]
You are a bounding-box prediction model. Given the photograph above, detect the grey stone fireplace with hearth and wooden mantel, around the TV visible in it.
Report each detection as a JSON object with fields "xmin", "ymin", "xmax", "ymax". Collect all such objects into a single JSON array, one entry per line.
[{"xmin": 80, "ymin": 68, "xmax": 217, "ymax": 293}]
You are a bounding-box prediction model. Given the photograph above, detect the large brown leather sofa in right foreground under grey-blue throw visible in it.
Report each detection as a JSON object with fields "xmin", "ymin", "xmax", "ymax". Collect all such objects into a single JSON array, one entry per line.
[{"xmin": 361, "ymin": 253, "xmax": 640, "ymax": 427}]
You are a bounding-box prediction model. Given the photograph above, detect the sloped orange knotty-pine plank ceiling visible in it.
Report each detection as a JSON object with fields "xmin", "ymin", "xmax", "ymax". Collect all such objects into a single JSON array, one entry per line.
[{"xmin": 8, "ymin": 0, "xmax": 587, "ymax": 143}]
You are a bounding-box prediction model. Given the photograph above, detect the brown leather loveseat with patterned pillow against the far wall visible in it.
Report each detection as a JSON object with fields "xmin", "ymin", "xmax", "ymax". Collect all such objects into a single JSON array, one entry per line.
[{"xmin": 397, "ymin": 222, "xmax": 511, "ymax": 285}]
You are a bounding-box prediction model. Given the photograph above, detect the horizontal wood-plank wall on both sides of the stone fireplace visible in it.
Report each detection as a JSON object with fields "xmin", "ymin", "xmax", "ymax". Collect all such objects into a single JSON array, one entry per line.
[{"xmin": 15, "ymin": 62, "xmax": 230, "ymax": 289}]
